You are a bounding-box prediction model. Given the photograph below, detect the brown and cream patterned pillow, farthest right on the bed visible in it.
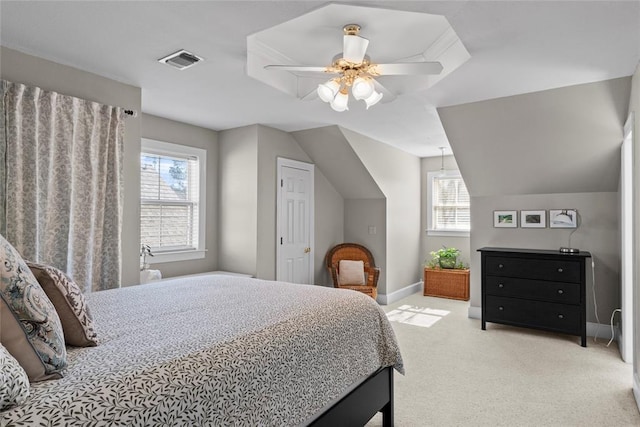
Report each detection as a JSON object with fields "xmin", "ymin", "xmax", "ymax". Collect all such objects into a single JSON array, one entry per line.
[{"xmin": 26, "ymin": 261, "xmax": 98, "ymax": 347}]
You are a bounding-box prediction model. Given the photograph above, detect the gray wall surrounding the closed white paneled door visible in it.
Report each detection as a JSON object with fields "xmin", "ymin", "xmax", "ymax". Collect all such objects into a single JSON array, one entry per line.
[{"xmin": 218, "ymin": 125, "xmax": 344, "ymax": 284}]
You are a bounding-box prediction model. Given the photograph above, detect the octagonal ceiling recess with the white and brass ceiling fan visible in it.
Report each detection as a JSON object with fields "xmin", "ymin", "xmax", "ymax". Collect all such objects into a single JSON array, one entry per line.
[{"xmin": 247, "ymin": 4, "xmax": 470, "ymax": 111}]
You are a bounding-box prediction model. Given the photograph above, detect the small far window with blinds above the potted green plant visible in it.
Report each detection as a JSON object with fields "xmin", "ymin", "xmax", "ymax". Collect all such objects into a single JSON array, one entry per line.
[{"xmin": 427, "ymin": 171, "xmax": 471, "ymax": 236}]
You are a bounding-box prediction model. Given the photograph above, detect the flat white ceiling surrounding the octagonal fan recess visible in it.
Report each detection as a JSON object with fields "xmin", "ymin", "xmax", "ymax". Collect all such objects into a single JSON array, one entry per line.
[{"xmin": 0, "ymin": 0, "xmax": 640, "ymax": 156}]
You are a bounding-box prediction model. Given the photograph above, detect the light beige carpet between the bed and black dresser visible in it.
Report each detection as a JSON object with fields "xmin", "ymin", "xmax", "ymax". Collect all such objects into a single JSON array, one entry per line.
[{"xmin": 367, "ymin": 294, "xmax": 640, "ymax": 427}]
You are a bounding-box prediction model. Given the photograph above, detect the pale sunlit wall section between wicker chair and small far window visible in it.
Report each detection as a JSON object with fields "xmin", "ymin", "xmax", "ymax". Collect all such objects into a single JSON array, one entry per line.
[{"xmin": 342, "ymin": 128, "xmax": 422, "ymax": 295}]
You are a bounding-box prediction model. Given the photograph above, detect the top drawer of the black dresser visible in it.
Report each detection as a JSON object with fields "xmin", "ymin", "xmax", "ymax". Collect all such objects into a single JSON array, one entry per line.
[{"xmin": 483, "ymin": 256, "xmax": 581, "ymax": 283}]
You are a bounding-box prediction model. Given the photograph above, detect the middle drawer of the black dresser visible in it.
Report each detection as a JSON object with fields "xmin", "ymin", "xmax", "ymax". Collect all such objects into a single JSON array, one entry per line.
[{"xmin": 485, "ymin": 276, "xmax": 580, "ymax": 305}]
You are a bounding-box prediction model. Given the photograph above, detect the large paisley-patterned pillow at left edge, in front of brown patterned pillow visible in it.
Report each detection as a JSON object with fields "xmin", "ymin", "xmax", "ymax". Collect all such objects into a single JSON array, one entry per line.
[{"xmin": 0, "ymin": 236, "xmax": 67, "ymax": 382}]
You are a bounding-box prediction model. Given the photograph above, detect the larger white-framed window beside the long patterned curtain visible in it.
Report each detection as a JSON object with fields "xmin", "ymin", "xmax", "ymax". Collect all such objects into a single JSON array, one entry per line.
[{"xmin": 140, "ymin": 138, "xmax": 206, "ymax": 262}]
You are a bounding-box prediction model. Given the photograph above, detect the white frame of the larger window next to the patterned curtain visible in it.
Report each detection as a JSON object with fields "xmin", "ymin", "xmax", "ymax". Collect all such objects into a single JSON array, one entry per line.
[{"xmin": 138, "ymin": 138, "xmax": 207, "ymax": 264}]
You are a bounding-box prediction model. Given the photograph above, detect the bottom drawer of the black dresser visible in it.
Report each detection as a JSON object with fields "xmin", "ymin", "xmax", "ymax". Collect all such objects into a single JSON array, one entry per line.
[{"xmin": 485, "ymin": 295, "xmax": 581, "ymax": 334}]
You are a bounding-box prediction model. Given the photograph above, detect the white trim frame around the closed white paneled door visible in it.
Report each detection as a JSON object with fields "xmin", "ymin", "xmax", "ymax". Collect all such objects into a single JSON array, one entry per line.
[{"xmin": 275, "ymin": 157, "xmax": 315, "ymax": 284}]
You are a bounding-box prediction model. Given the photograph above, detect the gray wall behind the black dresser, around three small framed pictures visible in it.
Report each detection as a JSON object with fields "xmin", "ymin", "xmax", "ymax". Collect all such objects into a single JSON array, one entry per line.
[{"xmin": 470, "ymin": 192, "xmax": 620, "ymax": 324}]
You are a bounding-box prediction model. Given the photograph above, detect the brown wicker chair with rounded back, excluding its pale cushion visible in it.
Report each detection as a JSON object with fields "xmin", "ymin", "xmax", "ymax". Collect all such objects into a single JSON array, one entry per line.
[{"xmin": 325, "ymin": 243, "xmax": 380, "ymax": 299}]
